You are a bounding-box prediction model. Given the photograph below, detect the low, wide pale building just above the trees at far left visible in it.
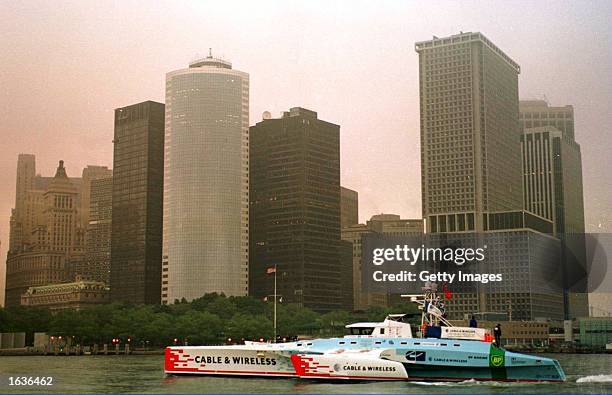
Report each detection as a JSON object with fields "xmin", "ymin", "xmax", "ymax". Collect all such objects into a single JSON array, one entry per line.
[{"xmin": 21, "ymin": 278, "xmax": 109, "ymax": 310}]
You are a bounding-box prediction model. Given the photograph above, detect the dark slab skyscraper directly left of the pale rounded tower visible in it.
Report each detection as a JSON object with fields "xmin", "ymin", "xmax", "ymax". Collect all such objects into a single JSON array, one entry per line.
[{"xmin": 110, "ymin": 101, "xmax": 164, "ymax": 304}]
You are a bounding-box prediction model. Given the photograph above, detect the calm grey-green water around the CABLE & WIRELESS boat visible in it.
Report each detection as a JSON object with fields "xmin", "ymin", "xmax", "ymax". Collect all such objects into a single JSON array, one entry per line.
[{"xmin": 0, "ymin": 354, "xmax": 612, "ymax": 394}]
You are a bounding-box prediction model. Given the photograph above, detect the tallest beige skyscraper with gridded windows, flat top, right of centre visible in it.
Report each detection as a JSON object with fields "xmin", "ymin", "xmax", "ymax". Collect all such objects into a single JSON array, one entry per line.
[{"xmin": 416, "ymin": 33, "xmax": 523, "ymax": 232}]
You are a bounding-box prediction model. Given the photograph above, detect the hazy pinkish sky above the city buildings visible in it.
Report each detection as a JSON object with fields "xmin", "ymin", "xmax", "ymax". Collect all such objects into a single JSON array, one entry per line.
[{"xmin": 0, "ymin": 0, "xmax": 612, "ymax": 300}]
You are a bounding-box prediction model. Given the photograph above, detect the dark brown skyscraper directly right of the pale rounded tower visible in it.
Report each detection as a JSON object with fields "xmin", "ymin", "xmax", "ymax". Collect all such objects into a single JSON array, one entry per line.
[{"xmin": 249, "ymin": 107, "xmax": 344, "ymax": 311}]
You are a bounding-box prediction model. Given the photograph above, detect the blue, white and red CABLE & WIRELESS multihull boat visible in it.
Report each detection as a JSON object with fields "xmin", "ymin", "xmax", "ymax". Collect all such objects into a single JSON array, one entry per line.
[{"xmin": 164, "ymin": 283, "xmax": 565, "ymax": 382}]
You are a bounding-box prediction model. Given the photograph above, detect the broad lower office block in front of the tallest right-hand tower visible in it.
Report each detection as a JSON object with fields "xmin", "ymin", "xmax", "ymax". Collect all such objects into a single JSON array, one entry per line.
[{"xmin": 425, "ymin": 229, "xmax": 564, "ymax": 321}]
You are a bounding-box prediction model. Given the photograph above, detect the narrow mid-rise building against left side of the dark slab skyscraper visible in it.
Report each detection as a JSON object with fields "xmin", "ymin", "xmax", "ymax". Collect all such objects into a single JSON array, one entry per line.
[{"xmin": 81, "ymin": 177, "xmax": 113, "ymax": 285}]
